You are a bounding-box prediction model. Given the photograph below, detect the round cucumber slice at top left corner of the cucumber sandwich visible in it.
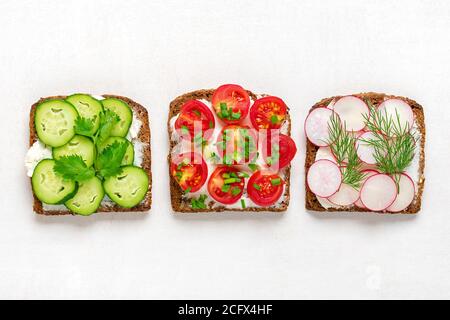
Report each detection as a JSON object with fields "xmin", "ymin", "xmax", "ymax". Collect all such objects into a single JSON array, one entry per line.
[{"xmin": 34, "ymin": 100, "xmax": 78, "ymax": 147}]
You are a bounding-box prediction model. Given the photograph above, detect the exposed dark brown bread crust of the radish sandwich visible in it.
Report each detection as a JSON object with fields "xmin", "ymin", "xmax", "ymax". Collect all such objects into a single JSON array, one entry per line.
[{"xmin": 305, "ymin": 92, "xmax": 426, "ymax": 214}]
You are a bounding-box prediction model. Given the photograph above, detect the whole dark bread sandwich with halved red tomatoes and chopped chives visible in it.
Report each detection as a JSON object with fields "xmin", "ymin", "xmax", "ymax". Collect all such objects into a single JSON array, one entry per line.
[{"xmin": 168, "ymin": 84, "xmax": 297, "ymax": 212}]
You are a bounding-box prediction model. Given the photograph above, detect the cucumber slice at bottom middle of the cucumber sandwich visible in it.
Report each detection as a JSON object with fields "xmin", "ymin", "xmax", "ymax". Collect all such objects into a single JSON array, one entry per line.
[{"xmin": 65, "ymin": 177, "xmax": 105, "ymax": 216}]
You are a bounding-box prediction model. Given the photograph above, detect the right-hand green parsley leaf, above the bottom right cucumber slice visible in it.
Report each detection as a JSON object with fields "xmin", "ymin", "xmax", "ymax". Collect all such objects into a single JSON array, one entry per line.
[{"xmin": 97, "ymin": 141, "xmax": 128, "ymax": 178}]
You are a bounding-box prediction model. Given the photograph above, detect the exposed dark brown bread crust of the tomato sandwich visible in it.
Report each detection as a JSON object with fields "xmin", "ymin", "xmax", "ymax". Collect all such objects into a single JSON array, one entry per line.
[{"xmin": 167, "ymin": 89, "xmax": 291, "ymax": 213}]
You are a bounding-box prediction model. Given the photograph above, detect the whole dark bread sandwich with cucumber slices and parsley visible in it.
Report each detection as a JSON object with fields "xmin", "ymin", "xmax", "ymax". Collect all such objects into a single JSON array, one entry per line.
[{"xmin": 25, "ymin": 94, "xmax": 152, "ymax": 216}]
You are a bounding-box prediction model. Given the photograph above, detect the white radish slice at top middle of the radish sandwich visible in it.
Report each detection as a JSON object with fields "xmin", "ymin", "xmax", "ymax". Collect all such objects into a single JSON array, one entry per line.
[{"xmin": 333, "ymin": 96, "xmax": 369, "ymax": 131}]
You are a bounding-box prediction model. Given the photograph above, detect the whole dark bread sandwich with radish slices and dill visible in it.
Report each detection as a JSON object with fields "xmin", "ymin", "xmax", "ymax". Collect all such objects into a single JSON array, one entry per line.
[{"xmin": 304, "ymin": 93, "xmax": 425, "ymax": 214}]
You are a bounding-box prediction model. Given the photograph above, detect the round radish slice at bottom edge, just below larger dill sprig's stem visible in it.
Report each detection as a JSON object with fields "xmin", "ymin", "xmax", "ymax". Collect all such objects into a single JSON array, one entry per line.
[{"xmin": 360, "ymin": 173, "xmax": 397, "ymax": 211}]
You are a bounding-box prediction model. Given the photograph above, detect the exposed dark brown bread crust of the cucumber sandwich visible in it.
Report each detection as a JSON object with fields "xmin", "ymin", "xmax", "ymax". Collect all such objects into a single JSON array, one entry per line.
[{"xmin": 29, "ymin": 94, "xmax": 152, "ymax": 216}]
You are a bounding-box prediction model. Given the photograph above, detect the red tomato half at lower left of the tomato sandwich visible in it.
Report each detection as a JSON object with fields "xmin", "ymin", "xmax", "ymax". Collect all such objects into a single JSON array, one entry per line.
[{"xmin": 170, "ymin": 152, "xmax": 208, "ymax": 192}]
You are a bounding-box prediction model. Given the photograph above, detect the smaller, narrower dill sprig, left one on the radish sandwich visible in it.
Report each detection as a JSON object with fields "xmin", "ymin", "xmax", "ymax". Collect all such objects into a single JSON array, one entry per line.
[{"xmin": 327, "ymin": 113, "xmax": 365, "ymax": 189}]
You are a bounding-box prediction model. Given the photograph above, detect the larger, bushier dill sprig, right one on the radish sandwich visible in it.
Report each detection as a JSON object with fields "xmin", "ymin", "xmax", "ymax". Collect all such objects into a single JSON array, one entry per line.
[{"xmin": 361, "ymin": 101, "xmax": 417, "ymax": 184}]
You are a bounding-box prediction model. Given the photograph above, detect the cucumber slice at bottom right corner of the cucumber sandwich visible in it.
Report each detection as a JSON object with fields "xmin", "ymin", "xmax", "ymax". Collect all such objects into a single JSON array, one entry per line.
[{"xmin": 103, "ymin": 166, "xmax": 149, "ymax": 208}]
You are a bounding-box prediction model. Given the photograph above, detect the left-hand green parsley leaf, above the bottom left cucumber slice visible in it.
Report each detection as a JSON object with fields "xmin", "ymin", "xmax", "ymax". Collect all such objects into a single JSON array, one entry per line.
[{"xmin": 53, "ymin": 155, "xmax": 95, "ymax": 182}]
